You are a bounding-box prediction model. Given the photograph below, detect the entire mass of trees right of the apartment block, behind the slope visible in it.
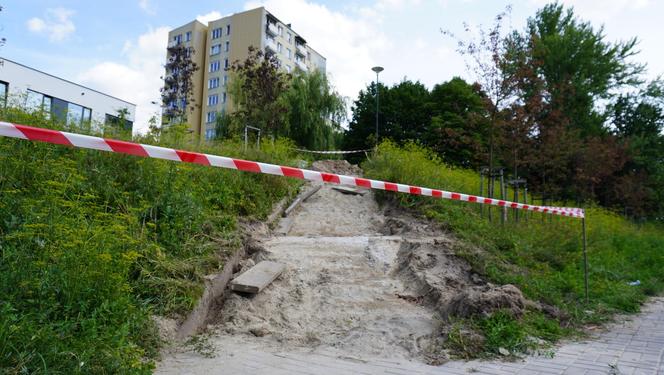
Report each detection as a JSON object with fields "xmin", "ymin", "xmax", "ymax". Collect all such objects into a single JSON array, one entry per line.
[{"xmin": 344, "ymin": 3, "xmax": 664, "ymax": 218}]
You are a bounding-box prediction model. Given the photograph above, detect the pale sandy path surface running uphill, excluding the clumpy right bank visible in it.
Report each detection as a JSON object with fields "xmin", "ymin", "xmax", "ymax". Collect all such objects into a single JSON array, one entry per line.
[{"xmin": 158, "ymin": 186, "xmax": 446, "ymax": 374}]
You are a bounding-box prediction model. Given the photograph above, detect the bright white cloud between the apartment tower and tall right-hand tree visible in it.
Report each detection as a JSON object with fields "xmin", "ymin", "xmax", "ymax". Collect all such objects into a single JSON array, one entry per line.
[{"xmin": 245, "ymin": 0, "xmax": 465, "ymax": 106}]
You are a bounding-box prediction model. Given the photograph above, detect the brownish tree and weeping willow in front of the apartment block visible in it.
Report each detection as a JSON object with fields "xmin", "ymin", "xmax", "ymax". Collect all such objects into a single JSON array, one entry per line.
[{"xmin": 223, "ymin": 48, "xmax": 346, "ymax": 150}]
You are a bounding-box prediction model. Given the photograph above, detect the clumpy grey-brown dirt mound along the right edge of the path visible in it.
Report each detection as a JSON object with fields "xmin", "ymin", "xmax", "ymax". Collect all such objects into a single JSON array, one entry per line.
[{"xmin": 395, "ymin": 239, "xmax": 528, "ymax": 318}]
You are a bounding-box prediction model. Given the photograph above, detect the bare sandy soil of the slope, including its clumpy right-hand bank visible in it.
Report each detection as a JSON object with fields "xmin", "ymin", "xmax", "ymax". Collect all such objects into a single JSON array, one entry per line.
[{"xmin": 158, "ymin": 160, "xmax": 524, "ymax": 373}]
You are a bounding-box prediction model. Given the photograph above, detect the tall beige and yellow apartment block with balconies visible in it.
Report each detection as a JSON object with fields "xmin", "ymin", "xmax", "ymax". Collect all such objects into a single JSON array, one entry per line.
[{"xmin": 166, "ymin": 7, "xmax": 326, "ymax": 139}]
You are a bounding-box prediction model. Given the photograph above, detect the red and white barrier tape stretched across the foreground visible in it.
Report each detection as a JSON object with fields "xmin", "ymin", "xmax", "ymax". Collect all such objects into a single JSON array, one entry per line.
[{"xmin": 0, "ymin": 122, "xmax": 585, "ymax": 218}]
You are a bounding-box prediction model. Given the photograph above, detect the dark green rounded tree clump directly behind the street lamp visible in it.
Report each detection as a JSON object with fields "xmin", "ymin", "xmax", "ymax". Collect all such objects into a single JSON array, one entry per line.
[{"xmin": 344, "ymin": 77, "xmax": 487, "ymax": 167}]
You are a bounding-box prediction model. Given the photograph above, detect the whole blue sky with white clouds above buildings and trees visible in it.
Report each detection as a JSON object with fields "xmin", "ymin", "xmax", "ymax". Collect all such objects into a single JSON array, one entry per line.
[{"xmin": 0, "ymin": 0, "xmax": 664, "ymax": 132}]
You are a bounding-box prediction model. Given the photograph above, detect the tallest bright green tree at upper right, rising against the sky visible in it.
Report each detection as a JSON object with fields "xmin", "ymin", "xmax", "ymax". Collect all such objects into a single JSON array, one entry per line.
[{"xmin": 504, "ymin": 3, "xmax": 644, "ymax": 137}]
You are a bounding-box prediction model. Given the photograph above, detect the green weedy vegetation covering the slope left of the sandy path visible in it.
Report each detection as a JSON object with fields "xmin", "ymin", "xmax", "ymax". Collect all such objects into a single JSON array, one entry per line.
[{"xmin": 0, "ymin": 109, "xmax": 298, "ymax": 374}]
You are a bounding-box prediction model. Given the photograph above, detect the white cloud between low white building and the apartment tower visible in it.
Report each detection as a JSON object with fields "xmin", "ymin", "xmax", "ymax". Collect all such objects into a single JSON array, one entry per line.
[{"xmin": 77, "ymin": 27, "xmax": 170, "ymax": 132}]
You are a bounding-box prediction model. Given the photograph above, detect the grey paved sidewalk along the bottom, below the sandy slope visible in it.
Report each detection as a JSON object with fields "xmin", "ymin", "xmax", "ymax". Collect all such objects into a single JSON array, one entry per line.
[{"xmin": 157, "ymin": 298, "xmax": 664, "ymax": 375}]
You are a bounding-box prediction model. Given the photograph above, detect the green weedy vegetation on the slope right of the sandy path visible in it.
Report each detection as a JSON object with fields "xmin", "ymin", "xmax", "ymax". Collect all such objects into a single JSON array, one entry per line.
[{"xmin": 363, "ymin": 142, "xmax": 664, "ymax": 356}]
